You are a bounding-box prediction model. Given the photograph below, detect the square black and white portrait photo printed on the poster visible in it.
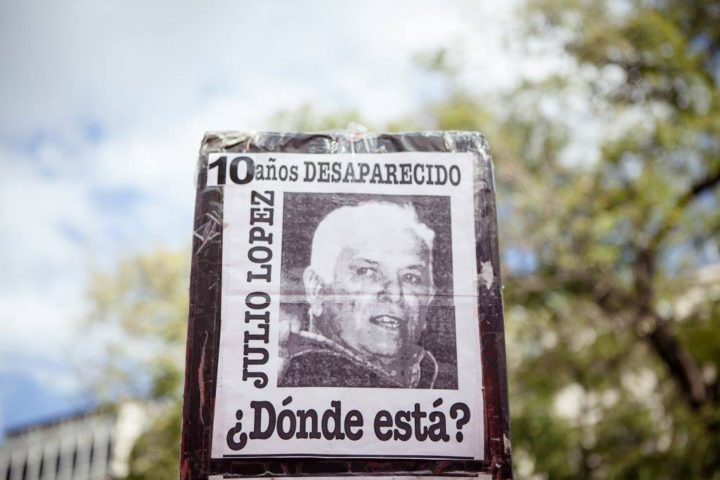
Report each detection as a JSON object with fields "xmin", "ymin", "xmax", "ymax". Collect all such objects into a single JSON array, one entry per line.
[{"xmin": 278, "ymin": 192, "xmax": 458, "ymax": 389}]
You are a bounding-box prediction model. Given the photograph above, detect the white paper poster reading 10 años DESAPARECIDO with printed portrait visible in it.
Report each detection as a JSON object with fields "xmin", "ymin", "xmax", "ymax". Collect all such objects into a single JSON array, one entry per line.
[{"xmin": 208, "ymin": 152, "xmax": 484, "ymax": 459}]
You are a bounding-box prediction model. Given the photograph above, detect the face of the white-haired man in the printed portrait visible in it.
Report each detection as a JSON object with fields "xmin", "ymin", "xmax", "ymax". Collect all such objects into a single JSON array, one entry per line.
[{"xmin": 321, "ymin": 230, "xmax": 433, "ymax": 363}]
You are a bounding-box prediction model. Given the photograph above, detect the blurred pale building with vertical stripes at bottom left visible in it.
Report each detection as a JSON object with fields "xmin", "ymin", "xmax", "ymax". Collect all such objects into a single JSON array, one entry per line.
[{"xmin": 0, "ymin": 402, "xmax": 147, "ymax": 480}]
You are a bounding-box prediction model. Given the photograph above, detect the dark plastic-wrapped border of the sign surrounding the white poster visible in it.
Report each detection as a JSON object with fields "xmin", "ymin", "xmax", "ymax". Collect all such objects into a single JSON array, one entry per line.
[{"xmin": 180, "ymin": 132, "xmax": 512, "ymax": 480}]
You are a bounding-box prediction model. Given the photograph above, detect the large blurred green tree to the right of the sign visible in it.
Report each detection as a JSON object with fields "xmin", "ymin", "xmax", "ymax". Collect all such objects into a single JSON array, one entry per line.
[{"xmin": 490, "ymin": 0, "xmax": 720, "ymax": 478}]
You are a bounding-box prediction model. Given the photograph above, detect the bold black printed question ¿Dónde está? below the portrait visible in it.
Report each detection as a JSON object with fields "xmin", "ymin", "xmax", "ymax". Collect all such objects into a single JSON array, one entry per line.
[{"xmin": 226, "ymin": 397, "xmax": 470, "ymax": 451}]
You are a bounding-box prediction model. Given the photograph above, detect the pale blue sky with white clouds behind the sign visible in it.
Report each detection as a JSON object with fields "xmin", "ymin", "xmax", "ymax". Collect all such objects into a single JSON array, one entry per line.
[{"xmin": 0, "ymin": 0, "xmax": 558, "ymax": 436}]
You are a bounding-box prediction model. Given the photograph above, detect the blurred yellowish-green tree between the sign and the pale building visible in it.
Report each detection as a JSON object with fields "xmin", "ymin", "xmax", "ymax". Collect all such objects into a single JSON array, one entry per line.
[{"xmin": 88, "ymin": 250, "xmax": 190, "ymax": 480}]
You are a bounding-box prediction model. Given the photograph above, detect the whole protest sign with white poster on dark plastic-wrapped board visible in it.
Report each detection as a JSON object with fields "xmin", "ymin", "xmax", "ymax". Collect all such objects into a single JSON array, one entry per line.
[{"xmin": 181, "ymin": 129, "xmax": 511, "ymax": 478}]
